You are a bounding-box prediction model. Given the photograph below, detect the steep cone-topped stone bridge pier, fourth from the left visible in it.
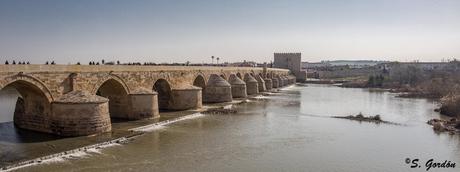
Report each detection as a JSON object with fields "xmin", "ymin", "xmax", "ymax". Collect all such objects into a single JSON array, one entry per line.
[{"xmin": 203, "ymin": 74, "xmax": 233, "ymax": 103}]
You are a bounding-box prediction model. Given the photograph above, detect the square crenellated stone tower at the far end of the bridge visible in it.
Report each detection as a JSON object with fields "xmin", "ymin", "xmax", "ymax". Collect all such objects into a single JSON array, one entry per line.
[{"xmin": 273, "ymin": 53, "xmax": 307, "ymax": 81}]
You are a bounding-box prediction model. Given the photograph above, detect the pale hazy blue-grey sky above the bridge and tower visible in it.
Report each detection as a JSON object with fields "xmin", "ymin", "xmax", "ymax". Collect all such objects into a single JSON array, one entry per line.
[{"xmin": 0, "ymin": 0, "xmax": 460, "ymax": 64}]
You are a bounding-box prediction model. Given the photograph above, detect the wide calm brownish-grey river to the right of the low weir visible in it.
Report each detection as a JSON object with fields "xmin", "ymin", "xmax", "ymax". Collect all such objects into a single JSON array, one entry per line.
[{"xmin": 0, "ymin": 85, "xmax": 460, "ymax": 172}]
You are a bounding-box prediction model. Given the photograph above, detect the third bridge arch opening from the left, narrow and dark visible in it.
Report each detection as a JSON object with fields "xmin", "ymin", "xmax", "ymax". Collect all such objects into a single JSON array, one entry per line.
[{"xmin": 152, "ymin": 78, "xmax": 172, "ymax": 110}]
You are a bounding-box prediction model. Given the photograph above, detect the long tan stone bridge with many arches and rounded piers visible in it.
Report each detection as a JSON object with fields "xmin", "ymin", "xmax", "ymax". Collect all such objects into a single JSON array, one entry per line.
[{"xmin": 0, "ymin": 65, "xmax": 295, "ymax": 136}]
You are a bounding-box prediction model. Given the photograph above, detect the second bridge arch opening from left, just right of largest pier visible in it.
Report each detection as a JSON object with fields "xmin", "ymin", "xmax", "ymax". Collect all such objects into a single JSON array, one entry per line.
[{"xmin": 96, "ymin": 78, "xmax": 129, "ymax": 119}]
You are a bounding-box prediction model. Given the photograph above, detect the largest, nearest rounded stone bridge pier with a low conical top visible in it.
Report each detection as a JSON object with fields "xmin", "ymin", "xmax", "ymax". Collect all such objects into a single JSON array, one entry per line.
[{"xmin": 50, "ymin": 91, "xmax": 112, "ymax": 136}]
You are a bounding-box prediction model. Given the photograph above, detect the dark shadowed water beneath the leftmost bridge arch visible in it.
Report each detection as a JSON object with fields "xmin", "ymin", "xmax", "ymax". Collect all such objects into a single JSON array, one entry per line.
[{"xmin": 0, "ymin": 122, "xmax": 63, "ymax": 143}]
